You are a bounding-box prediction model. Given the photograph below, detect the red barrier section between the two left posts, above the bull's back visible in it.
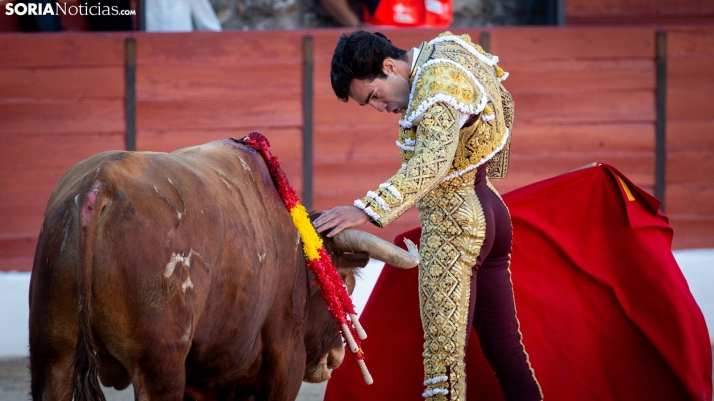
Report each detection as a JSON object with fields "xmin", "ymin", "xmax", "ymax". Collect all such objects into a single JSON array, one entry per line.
[{"xmin": 136, "ymin": 31, "xmax": 302, "ymax": 186}]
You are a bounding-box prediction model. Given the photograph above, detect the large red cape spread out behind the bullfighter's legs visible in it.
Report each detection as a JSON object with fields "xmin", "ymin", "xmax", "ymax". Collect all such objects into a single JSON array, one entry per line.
[{"xmin": 325, "ymin": 164, "xmax": 712, "ymax": 401}]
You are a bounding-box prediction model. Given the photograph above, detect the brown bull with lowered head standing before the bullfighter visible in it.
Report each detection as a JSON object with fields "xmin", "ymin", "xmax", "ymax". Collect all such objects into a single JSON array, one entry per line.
[{"xmin": 30, "ymin": 141, "xmax": 413, "ymax": 400}]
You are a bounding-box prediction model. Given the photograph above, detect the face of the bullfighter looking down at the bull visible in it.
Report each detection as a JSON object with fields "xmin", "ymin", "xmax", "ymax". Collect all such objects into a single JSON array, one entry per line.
[{"xmin": 350, "ymin": 58, "xmax": 409, "ymax": 114}]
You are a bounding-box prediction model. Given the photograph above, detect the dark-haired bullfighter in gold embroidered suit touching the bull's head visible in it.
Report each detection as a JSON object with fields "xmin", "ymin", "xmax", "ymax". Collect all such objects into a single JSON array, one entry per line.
[{"xmin": 314, "ymin": 31, "xmax": 543, "ymax": 401}]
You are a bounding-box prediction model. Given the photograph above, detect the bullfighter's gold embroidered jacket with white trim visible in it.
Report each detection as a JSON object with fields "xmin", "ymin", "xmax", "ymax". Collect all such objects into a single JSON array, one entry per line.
[{"xmin": 355, "ymin": 31, "xmax": 513, "ymax": 227}]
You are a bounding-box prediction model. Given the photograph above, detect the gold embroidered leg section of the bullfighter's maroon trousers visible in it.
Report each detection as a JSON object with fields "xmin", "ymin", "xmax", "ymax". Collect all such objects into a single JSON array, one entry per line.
[{"xmin": 417, "ymin": 172, "xmax": 486, "ymax": 401}]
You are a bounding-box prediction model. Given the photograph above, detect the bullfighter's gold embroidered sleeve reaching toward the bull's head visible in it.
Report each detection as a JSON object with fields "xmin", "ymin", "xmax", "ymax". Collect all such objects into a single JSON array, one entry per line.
[{"xmin": 354, "ymin": 103, "xmax": 460, "ymax": 227}]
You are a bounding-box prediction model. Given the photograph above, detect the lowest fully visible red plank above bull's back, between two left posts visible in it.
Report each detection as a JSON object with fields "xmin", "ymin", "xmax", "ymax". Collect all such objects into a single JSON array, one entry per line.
[{"xmin": 137, "ymin": 94, "xmax": 302, "ymax": 130}]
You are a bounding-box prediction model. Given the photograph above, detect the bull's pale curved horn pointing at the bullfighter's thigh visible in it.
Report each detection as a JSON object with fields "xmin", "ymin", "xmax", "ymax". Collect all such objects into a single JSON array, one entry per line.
[{"xmin": 333, "ymin": 228, "xmax": 419, "ymax": 269}]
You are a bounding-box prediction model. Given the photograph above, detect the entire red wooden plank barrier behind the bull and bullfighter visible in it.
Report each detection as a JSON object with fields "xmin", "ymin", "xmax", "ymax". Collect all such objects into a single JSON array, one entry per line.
[{"xmin": 0, "ymin": 28, "xmax": 714, "ymax": 271}]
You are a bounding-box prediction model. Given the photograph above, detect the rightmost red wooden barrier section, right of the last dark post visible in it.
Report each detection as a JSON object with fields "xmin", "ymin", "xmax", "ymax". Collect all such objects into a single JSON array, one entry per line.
[{"xmin": 666, "ymin": 28, "xmax": 714, "ymax": 248}]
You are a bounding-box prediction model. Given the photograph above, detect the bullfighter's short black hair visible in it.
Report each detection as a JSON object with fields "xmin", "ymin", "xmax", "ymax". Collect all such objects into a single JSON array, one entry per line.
[{"xmin": 330, "ymin": 31, "xmax": 407, "ymax": 102}]
